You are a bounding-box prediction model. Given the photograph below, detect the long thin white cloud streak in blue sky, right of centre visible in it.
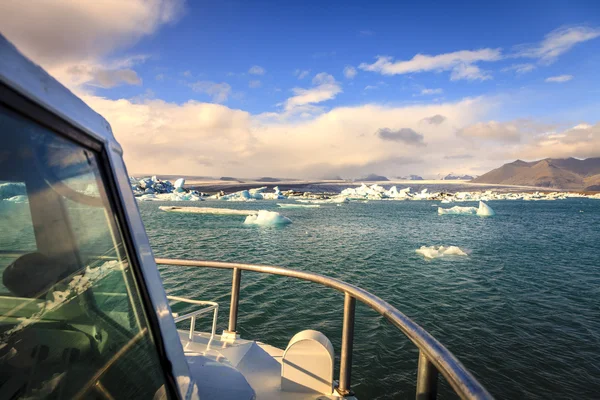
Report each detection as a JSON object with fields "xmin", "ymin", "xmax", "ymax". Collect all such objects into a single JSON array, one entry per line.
[{"xmin": 358, "ymin": 48, "xmax": 502, "ymax": 80}]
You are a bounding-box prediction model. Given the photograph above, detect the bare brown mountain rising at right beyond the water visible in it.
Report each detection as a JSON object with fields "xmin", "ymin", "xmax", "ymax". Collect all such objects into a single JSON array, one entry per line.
[{"xmin": 472, "ymin": 157, "xmax": 600, "ymax": 190}]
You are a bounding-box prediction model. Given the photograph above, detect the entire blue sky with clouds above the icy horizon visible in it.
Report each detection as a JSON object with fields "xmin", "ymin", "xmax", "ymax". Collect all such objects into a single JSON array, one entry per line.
[{"xmin": 0, "ymin": 0, "xmax": 600, "ymax": 178}]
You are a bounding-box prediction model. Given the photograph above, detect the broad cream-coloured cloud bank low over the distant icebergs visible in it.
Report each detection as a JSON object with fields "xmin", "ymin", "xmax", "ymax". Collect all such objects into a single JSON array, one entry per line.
[{"xmin": 83, "ymin": 92, "xmax": 489, "ymax": 177}]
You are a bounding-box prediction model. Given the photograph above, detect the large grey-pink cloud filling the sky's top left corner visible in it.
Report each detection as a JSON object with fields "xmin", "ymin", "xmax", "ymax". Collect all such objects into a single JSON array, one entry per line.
[{"xmin": 0, "ymin": 0, "xmax": 184, "ymax": 68}]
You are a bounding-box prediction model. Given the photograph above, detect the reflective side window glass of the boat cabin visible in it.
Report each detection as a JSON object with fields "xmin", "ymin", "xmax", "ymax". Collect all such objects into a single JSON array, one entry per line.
[{"xmin": 0, "ymin": 108, "xmax": 169, "ymax": 399}]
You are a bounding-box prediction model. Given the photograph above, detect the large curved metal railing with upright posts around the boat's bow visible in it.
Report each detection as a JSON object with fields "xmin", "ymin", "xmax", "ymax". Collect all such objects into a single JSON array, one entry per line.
[{"xmin": 156, "ymin": 258, "xmax": 493, "ymax": 400}]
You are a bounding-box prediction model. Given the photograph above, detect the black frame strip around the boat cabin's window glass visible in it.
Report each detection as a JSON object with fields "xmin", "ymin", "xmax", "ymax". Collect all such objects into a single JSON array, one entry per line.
[{"xmin": 0, "ymin": 80, "xmax": 180, "ymax": 399}]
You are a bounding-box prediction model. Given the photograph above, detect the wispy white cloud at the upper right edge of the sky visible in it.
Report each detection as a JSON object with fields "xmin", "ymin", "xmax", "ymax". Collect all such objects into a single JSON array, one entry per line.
[{"xmin": 513, "ymin": 26, "xmax": 600, "ymax": 65}]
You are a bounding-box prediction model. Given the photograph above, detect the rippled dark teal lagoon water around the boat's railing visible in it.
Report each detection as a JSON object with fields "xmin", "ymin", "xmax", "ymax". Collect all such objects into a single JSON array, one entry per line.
[{"xmin": 140, "ymin": 199, "xmax": 600, "ymax": 399}]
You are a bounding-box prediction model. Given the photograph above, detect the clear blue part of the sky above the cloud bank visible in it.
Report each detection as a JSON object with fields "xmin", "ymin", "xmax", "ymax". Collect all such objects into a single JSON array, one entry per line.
[{"xmin": 103, "ymin": 1, "xmax": 600, "ymax": 117}]
